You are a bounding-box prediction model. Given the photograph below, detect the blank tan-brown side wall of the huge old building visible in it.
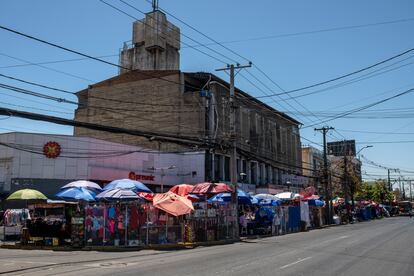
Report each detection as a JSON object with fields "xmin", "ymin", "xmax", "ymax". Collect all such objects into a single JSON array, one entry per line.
[{"xmin": 75, "ymin": 72, "xmax": 204, "ymax": 150}]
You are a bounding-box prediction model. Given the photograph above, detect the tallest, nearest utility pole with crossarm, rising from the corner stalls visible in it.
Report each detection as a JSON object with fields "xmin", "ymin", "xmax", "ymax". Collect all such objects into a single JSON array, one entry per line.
[{"xmin": 216, "ymin": 62, "xmax": 252, "ymax": 239}]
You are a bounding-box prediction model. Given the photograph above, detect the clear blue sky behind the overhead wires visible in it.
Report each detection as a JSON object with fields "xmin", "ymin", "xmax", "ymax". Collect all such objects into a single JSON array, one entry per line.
[{"xmin": 0, "ymin": 0, "xmax": 414, "ymax": 185}]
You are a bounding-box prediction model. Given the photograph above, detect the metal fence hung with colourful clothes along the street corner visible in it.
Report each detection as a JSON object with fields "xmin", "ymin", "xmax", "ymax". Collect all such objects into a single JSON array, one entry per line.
[{"xmin": 84, "ymin": 202, "xmax": 238, "ymax": 246}]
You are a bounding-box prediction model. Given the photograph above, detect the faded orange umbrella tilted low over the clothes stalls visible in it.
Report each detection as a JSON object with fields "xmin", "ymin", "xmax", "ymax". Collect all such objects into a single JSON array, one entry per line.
[{"xmin": 153, "ymin": 192, "xmax": 194, "ymax": 216}]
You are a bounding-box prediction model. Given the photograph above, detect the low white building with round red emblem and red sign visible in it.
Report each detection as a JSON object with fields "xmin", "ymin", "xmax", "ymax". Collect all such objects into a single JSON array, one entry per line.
[{"xmin": 0, "ymin": 132, "xmax": 205, "ymax": 197}]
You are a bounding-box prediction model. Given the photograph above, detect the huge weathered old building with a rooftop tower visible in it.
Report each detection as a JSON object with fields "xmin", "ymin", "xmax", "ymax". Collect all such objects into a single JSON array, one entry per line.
[{"xmin": 75, "ymin": 11, "xmax": 303, "ymax": 194}]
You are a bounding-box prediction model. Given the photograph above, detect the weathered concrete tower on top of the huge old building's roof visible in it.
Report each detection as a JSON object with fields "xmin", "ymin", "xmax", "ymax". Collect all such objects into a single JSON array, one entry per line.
[{"xmin": 119, "ymin": 6, "xmax": 180, "ymax": 74}]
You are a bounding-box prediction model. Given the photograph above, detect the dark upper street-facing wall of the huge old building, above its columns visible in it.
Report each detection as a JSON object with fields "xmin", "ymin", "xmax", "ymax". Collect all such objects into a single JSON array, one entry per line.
[{"xmin": 212, "ymin": 82, "xmax": 302, "ymax": 172}]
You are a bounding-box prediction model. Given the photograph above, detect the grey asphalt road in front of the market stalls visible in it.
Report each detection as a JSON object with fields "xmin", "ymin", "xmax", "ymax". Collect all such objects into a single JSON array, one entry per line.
[{"xmin": 0, "ymin": 217, "xmax": 414, "ymax": 276}]
